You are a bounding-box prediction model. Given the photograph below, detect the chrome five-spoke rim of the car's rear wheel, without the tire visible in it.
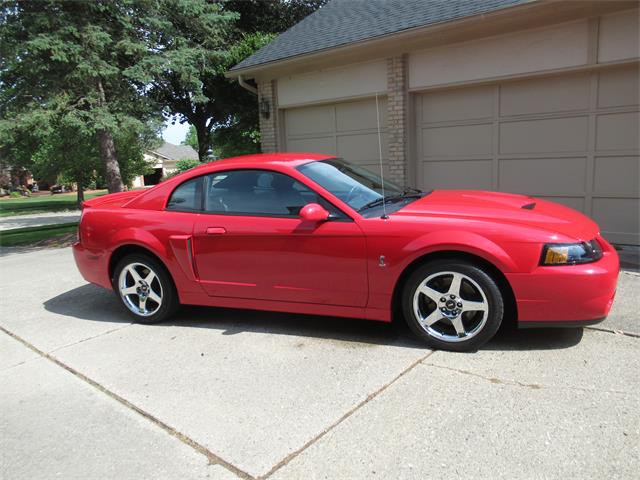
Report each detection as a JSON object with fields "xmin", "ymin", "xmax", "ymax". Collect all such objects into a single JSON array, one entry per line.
[{"xmin": 118, "ymin": 262, "xmax": 162, "ymax": 317}]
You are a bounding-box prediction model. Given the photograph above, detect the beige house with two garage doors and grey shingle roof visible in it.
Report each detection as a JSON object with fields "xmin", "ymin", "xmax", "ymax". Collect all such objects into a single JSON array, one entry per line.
[{"xmin": 228, "ymin": 0, "xmax": 640, "ymax": 245}]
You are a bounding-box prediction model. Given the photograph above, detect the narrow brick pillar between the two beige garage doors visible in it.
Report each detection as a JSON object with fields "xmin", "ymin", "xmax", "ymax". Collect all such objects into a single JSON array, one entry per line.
[{"xmin": 387, "ymin": 55, "xmax": 408, "ymax": 185}]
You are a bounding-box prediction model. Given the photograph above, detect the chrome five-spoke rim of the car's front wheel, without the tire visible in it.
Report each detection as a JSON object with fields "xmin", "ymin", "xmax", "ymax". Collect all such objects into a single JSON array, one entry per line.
[{"xmin": 413, "ymin": 272, "xmax": 489, "ymax": 343}]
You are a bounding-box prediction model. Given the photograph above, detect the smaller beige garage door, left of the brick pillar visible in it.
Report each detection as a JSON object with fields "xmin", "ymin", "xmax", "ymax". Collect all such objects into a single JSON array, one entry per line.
[{"xmin": 284, "ymin": 98, "xmax": 389, "ymax": 175}]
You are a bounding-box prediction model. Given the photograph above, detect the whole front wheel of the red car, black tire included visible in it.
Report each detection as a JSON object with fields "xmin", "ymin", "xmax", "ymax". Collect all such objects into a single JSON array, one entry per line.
[{"xmin": 401, "ymin": 258, "xmax": 504, "ymax": 352}]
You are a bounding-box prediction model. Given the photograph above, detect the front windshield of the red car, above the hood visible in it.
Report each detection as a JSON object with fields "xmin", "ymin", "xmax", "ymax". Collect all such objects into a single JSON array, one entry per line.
[{"xmin": 298, "ymin": 158, "xmax": 406, "ymax": 210}]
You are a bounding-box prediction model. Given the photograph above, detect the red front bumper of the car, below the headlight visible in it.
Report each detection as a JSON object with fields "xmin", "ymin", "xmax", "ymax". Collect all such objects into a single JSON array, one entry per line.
[{"xmin": 506, "ymin": 237, "xmax": 620, "ymax": 327}]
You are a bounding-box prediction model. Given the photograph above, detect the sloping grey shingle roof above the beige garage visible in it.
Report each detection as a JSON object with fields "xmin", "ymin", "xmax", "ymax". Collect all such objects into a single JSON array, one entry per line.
[{"xmin": 231, "ymin": 0, "xmax": 533, "ymax": 72}]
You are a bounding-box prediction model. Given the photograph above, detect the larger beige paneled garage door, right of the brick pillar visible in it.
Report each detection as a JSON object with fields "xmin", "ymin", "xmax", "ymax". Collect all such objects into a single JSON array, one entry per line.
[{"xmin": 415, "ymin": 65, "xmax": 640, "ymax": 244}]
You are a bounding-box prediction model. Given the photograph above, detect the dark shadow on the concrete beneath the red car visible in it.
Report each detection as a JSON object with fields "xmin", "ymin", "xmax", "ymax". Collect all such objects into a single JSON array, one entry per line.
[{"xmin": 43, "ymin": 284, "xmax": 582, "ymax": 351}]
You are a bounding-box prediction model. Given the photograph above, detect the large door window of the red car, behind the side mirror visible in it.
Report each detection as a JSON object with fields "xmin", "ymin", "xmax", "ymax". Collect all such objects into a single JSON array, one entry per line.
[{"xmin": 205, "ymin": 170, "xmax": 318, "ymax": 217}]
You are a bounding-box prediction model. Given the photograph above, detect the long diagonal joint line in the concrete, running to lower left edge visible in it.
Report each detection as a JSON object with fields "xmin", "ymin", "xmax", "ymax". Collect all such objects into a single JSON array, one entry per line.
[{"xmin": 0, "ymin": 326, "xmax": 255, "ymax": 480}]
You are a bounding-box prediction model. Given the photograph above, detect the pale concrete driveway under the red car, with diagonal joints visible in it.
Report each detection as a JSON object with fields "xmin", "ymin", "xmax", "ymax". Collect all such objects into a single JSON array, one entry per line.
[{"xmin": 0, "ymin": 249, "xmax": 640, "ymax": 479}]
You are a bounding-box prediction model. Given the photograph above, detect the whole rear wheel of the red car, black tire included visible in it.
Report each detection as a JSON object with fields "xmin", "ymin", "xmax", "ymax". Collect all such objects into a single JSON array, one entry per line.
[{"xmin": 111, "ymin": 254, "xmax": 179, "ymax": 324}]
